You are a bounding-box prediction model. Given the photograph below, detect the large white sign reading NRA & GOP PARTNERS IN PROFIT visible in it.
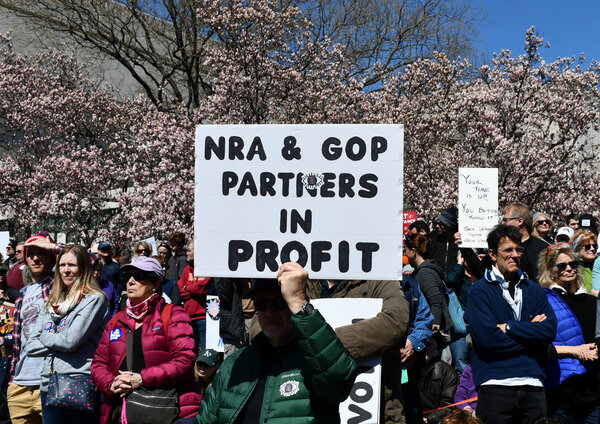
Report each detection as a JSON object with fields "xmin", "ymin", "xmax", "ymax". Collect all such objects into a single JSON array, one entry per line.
[{"xmin": 194, "ymin": 125, "xmax": 403, "ymax": 280}]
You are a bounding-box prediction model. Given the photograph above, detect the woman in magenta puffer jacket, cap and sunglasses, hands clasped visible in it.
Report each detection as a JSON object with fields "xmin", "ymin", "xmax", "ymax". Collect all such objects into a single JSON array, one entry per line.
[{"xmin": 92, "ymin": 256, "xmax": 202, "ymax": 423}]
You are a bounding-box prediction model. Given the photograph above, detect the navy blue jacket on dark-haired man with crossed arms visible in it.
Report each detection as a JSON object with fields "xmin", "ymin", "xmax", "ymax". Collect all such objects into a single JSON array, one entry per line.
[{"xmin": 465, "ymin": 271, "xmax": 556, "ymax": 387}]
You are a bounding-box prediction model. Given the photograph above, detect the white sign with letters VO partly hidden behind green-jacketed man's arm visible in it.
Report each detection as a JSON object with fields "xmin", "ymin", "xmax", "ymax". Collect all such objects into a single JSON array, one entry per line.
[{"xmin": 310, "ymin": 299, "xmax": 383, "ymax": 424}]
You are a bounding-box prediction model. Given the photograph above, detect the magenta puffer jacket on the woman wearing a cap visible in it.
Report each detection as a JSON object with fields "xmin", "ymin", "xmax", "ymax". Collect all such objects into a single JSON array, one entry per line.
[{"xmin": 92, "ymin": 299, "xmax": 202, "ymax": 423}]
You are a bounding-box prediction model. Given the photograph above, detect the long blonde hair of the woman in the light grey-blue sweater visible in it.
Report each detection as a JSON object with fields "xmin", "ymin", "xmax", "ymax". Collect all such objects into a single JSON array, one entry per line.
[{"xmin": 46, "ymin": 244, "xmax": 107, "ymax": 312}]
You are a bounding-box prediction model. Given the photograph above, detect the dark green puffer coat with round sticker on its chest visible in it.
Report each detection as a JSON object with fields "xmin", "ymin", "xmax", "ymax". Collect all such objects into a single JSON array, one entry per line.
[{"xmin": 196, "ymin": 310, "xmax": 358, "ymax": 424}]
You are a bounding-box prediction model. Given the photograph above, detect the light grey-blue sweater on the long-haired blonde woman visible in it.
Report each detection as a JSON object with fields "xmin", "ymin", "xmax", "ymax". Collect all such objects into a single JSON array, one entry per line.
[{"xmin": 25, "ymin": 293, "xmax": 108, "ymax": 392}]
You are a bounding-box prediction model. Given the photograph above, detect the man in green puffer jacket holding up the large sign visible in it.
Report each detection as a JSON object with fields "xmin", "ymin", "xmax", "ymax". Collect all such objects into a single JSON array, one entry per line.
[{"xmin": 196, "ymin": 262, "xmax": 358, "ymax": 424}]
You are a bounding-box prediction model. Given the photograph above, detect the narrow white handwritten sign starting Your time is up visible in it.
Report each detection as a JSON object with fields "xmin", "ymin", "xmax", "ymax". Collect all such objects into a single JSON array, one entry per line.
[{"xmin": 458, "ymin": 168, "xmax": 498, "ymax": 248}]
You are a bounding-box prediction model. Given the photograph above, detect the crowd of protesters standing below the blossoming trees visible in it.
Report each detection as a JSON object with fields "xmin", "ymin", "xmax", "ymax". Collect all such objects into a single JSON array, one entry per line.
[{"xmin": 0, "ymin": 203, "xmax": 600, "ymax": 424}]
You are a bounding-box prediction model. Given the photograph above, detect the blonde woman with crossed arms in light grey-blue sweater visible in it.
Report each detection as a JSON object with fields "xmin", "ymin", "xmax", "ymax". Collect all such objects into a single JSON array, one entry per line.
[{"xmin": 27, "ymin": 245, "xmax": 108, "ymax": 424}]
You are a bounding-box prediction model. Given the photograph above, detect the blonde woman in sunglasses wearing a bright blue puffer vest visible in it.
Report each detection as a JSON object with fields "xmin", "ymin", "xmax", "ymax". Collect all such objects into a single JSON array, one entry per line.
[{"xmin": 538, "ymin": 243, "xmax": 600, "ymax": 423}]
